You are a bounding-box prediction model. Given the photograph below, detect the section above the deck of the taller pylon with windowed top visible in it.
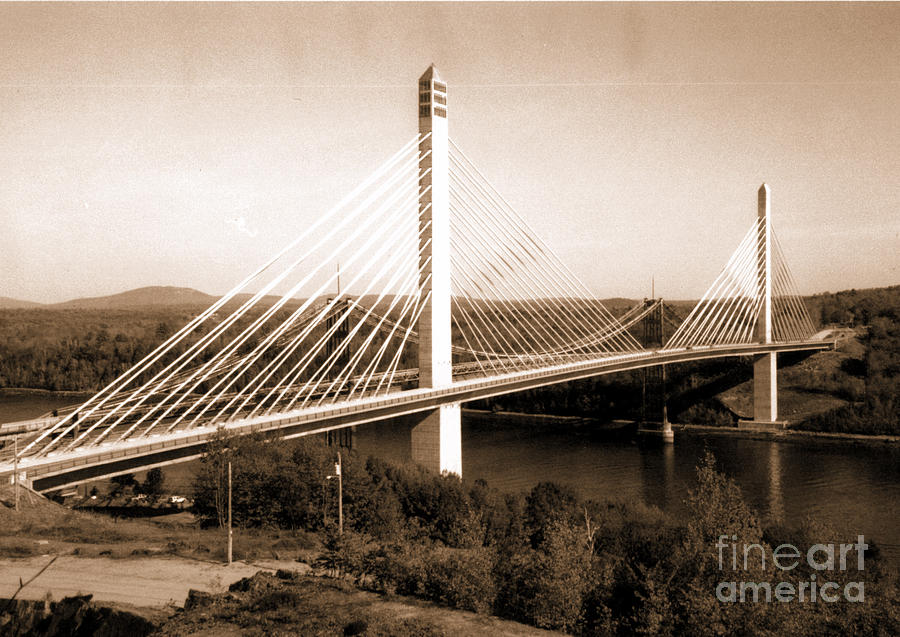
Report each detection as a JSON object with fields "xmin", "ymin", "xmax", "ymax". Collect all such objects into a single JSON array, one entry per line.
[{"xmin": 418, "ymin": 64, "xmax": 453, "ymax": 387}]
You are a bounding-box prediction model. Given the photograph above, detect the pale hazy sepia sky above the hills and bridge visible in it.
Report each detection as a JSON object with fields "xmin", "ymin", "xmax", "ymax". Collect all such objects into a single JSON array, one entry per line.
[{"xmin": 0, "ymin": 3, "xmax": 900, "ymax": 302}]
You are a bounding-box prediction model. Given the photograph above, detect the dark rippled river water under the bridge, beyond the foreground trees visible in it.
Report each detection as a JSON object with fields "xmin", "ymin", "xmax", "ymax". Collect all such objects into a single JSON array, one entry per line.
[{"xmin": 357, "ymin": 415, "xmax": 900, "ymax": 563}]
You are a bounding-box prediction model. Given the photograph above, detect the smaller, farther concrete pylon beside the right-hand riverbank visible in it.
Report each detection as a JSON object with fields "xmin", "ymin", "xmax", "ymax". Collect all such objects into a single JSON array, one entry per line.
[{"xmin": 753, "ymin": 184, "xmax": 781, "ymax": 425}]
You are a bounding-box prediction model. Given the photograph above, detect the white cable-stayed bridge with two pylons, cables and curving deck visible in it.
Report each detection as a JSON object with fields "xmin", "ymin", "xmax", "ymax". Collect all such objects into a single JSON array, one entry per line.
[{"xmin": 0, "ymin": 66, "xmax": 833, "ymax": 490}]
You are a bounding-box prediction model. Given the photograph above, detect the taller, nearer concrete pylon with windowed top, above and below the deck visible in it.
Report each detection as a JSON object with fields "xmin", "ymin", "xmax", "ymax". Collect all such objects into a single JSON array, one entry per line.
[{"xmin": 412, "ymin": 65, "xmax": 462, "ymax": 475}]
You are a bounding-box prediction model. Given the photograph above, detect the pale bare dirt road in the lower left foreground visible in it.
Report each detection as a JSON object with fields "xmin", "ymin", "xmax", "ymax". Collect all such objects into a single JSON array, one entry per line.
[{"xmin": 0, "ymin": 556, "xmax": 302, "ymax": 607}]
